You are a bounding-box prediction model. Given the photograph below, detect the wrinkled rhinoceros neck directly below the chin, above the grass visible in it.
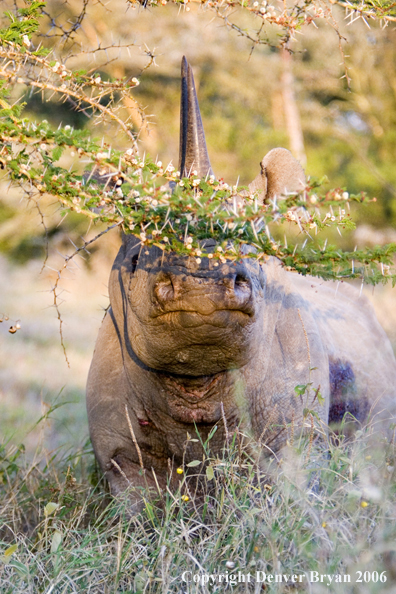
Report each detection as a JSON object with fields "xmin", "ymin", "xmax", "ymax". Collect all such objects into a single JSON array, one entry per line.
[{"xmin": 121, "ymin": 352, "xmax": 251, "ymax": 460}]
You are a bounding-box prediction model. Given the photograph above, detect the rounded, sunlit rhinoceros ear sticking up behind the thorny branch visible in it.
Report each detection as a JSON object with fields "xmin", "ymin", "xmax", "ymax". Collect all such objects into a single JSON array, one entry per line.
[{"xmin": 249, "ymin": 148, "xmax": 306, "ymax": 202}]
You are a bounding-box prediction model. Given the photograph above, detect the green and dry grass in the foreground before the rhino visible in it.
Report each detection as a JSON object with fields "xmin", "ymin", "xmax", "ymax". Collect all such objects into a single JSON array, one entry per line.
[{"xmin": 0, "ymin": 410, "xmax": 396, "ymax": 594}]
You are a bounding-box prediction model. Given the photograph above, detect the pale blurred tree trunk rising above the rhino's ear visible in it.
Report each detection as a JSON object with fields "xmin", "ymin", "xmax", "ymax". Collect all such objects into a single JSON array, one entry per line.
[{"xmin": 281, "ymin": 49, "xmax": 307, "ymax": 167}]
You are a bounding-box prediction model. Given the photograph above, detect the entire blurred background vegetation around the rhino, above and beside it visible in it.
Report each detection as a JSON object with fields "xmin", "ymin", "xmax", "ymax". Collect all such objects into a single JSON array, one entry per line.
[{"xmin": 0, "ymin": 0, "xmax": 396, "ymax": 444}]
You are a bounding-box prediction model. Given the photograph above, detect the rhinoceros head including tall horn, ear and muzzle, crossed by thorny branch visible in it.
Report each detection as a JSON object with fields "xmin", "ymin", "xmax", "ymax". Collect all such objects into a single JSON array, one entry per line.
[{"xmin": 109, "ymin": 58, "xmax": 305, "ymax": 376}]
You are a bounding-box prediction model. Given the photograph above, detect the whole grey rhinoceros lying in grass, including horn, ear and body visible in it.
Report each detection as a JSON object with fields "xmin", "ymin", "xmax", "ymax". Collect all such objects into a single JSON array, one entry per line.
[{"xmin": 87, "ymin": 58, "xmax": 396, "ymax": 502}]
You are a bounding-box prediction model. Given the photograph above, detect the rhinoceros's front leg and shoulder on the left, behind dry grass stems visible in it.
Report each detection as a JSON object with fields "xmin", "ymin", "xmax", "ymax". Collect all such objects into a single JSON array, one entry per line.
[{"xmin": 87, "ymin": 310, "xmax": 167, "ymax": 511}]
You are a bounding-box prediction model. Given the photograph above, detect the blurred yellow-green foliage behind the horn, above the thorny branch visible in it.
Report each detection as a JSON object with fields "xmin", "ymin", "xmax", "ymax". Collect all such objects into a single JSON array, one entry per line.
[{"xmin": 0, "ymin": 0, "xmax": 396, "ymax": 261}]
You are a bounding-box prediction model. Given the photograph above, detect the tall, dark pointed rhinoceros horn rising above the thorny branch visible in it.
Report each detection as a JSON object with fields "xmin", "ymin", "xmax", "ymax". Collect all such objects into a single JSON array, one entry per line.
[{"xmin": 179, "ymin": 56, "xmax": 213, "ymax": 177}]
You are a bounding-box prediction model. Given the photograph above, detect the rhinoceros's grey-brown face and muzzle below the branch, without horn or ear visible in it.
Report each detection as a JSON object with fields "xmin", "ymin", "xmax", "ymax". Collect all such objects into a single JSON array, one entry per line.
[{"xmin": 110, "ymin": 239, "xmax": 264, "ymax": 376}]
